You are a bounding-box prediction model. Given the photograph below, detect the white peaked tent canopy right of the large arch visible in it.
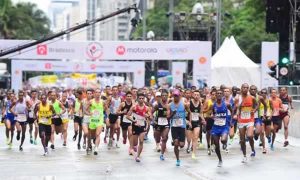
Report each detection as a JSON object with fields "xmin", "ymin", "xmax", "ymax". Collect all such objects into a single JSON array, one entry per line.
[{"xmin": 211, "ymin": 36, "xmax": 260, "ymax": 87}]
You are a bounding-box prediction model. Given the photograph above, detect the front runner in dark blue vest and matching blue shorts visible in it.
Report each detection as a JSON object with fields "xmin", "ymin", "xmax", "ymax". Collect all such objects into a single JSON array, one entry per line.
[{"xmin": 211, "ymin": 88, "xmax": 232, "ymax": 167}]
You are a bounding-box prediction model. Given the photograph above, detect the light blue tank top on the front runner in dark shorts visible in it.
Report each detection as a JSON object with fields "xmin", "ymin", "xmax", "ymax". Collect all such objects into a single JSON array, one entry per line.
[{"xmin": 170, "ymin": 101, "xmax": 186, "ymax": 128}]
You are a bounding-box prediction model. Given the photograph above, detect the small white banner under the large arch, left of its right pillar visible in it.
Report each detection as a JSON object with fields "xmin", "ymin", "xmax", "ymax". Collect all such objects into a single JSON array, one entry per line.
[{"xmin": 172, "ymin": 62, "xmax": 187, "ymax": 86}]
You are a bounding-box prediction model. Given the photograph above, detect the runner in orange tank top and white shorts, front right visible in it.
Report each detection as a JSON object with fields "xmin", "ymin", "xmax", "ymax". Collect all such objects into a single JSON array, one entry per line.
[{"xmin": 235, "ymin": 83, "xmax": 258, "ymax": 163}]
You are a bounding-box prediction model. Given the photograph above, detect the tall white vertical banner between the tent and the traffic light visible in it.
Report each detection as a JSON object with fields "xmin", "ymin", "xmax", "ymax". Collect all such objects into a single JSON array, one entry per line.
[{"xmin": 261, "ymin": 42, "xmax": 279, "ymax": 88}]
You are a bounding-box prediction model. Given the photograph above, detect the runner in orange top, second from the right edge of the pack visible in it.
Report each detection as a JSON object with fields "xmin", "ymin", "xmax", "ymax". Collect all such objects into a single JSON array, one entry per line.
[{"xmin": 270, "ymin": 89, "xmax": 285, "ymax": 151}]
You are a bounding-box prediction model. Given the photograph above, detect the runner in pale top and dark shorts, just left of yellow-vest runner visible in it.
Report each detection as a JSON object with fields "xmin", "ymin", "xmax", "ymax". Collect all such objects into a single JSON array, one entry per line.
[{"xmin": 27, "ymin": 90, "xmax": 40, "ymax": 145}]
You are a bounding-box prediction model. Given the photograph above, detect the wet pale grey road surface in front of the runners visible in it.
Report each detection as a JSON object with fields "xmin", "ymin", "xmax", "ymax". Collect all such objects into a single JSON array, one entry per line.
[{"xmin": 0, "ymin": 124, "xmax": 300, "ymax": 180}]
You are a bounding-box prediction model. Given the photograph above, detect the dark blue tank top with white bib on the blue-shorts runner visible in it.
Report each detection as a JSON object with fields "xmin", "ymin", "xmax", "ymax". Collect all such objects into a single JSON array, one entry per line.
[{"xmin": 213, "ymin": 100, "xmax": 230, "ymax": 127}]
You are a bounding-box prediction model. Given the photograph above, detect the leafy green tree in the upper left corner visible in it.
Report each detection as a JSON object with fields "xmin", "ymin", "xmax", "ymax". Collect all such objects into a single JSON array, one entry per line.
[{"xmin": 0, "ymin": 0, "xmax": 50, "ymax": 39}]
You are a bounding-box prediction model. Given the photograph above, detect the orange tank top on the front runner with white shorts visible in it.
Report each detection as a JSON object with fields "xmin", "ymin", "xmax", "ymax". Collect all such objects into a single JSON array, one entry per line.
[{"xmin": 239, "ymin": 95, "xmax": 254, "ymax": 123}]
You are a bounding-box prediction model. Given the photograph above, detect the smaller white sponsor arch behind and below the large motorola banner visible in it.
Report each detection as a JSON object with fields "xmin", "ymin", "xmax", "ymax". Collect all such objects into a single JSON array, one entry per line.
[{"xmin": 11, "ymin": 60, "xmax": 145, "ymax": 90}]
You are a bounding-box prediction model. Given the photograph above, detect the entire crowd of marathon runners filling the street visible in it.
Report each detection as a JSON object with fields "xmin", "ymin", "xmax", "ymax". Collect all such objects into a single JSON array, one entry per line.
[{"xmin": 2, "ymin": 84, "xmax": 293, "ymax": 167}]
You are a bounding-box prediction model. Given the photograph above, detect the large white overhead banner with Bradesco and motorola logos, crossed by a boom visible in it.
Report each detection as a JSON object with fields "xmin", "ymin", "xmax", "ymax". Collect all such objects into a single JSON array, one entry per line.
[{"xmin": 0, "ymin": 40, "xmax": 208, "ymax": 60}]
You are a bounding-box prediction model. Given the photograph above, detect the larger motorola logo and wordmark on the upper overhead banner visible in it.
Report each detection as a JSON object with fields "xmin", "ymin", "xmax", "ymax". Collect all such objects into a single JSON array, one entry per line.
[{"xmin": 116, "ymin": 45, "xmax": 158, "ymax": 56}]
